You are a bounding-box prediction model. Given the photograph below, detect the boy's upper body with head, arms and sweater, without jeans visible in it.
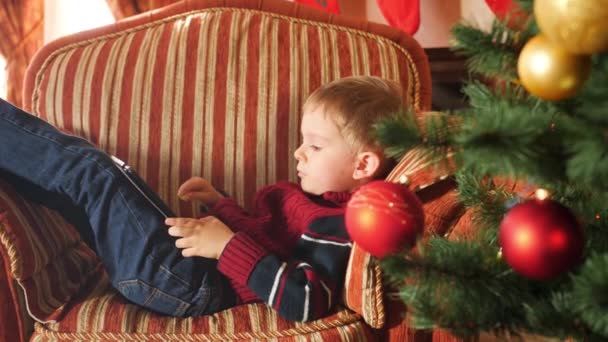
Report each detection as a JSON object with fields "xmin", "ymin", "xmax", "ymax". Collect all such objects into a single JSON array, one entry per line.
[{"xmin": 165, "ymin": 77, "xmax": 401, "ymax": 321}]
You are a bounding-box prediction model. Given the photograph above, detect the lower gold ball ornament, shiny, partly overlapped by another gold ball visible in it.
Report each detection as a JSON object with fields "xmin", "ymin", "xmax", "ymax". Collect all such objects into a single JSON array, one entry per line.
[{"xmin": 517, "ymin": 34, "xmax": 591, "ymax": 101}]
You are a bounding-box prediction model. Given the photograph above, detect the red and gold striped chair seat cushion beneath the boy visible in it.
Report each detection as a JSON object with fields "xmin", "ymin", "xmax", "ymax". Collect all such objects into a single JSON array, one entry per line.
[{"xmin": 32, "ymin": 288, "xmax": 374, "ymax": 341}]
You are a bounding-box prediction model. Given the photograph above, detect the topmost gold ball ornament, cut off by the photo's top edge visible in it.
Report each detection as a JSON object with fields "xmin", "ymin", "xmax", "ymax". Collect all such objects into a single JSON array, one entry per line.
[{"xmin": 534, "ymin": 0, "xmax": 608, "ymax": 55}]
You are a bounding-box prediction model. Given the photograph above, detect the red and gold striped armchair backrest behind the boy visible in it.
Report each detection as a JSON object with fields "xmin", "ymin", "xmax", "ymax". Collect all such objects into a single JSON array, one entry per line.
[{"xmin": 24, "ymin": 0, "xmax": 430, "ymax": 215}]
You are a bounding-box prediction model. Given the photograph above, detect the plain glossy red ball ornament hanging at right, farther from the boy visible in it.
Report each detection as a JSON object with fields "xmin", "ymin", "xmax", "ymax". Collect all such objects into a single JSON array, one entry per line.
[{"xmin": 499, "ymin": 199, "xmax": 585, "ymax": 280}]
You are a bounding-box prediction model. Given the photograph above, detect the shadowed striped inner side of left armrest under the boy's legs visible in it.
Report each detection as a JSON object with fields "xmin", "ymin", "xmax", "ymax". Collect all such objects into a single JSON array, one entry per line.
[{"xmin": 0, "ymin": 179, "xmax": 109, "ymax": 322}]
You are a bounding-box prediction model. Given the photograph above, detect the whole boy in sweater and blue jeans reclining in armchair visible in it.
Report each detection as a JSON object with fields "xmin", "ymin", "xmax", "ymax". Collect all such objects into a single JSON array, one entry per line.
[{"xmin": 0, "ymin": 77, "xmax": 401, "ymax": 320}]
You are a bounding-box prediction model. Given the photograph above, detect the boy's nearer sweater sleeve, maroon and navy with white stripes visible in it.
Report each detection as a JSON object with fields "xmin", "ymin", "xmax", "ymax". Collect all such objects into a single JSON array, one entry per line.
[{"xmin": 218, "ymin": 185, "xmax": 352, "ymax": 321}]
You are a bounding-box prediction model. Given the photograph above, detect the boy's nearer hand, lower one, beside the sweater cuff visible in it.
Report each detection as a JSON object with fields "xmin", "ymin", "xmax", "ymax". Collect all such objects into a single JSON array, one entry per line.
[{"xmin": 165, "ymin": 216, "xmax": 234, "ymax": 259}]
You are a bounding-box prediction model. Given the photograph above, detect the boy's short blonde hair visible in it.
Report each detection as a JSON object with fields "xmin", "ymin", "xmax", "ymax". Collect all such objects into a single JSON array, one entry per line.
[{"xmin": 303, "ymin": 76, "xmax": 404, "ymax": 176}]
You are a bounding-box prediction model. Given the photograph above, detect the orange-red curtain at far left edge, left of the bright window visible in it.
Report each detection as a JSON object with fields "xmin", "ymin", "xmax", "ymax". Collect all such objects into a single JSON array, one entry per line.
[{"xmin": 0, "ymin": 0, "xmax": 44, "ymax": 106}]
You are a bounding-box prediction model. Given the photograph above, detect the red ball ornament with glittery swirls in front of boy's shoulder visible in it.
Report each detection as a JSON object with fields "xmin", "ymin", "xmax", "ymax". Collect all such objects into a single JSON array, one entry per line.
[{"xmin": 345, "ymin": 181, "xmax": 424, "ymax": 258}]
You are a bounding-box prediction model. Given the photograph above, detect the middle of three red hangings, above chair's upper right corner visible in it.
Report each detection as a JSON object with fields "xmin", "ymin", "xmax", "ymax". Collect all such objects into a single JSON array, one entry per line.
[{"xmin": 376, "ymin": 0, "xmax": 420, "ymax": 34}]
